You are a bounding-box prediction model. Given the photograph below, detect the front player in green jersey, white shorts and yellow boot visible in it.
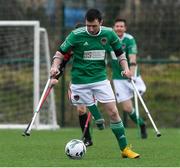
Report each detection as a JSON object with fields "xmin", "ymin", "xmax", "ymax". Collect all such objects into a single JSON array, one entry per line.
[{"xmin": 50, "ymin": 9, "xmax": 140, "ymax": 158}]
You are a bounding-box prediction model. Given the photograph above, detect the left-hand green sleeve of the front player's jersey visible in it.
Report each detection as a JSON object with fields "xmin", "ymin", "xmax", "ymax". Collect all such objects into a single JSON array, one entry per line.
[{"xmin": 58, "ymin": 32, "xmax": 76, "ymax": 54}]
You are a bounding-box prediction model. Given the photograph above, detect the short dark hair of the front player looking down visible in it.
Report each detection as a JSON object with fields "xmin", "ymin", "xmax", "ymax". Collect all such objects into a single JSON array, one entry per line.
[{"xmin": 85, "ymin": 9, "xmax": 102, "ymax": 22}]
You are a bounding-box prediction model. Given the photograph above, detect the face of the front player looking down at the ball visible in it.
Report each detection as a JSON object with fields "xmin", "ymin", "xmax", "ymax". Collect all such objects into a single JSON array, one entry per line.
[{"xmin": 86, "ymin": 19, "xmax": 102, "ymax": 35}]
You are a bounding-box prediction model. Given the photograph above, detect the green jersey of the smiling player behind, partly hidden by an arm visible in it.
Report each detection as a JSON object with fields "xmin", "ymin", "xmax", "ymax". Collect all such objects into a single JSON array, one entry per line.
[{"xmin": 111, "ymin": 33, "xmax": 139, "ymax": 79}]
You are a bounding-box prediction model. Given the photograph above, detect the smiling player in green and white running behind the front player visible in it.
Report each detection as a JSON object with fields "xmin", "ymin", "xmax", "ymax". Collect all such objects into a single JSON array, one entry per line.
[{"xmin": 111, "ymin": 19, "xmax": 147, "ymax": 139}]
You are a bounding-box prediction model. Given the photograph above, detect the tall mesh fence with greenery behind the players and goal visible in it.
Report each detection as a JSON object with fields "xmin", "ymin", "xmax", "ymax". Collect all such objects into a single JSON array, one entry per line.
[{"xmin": 0, "ymin": 0, "xmax": 180, "ymax": 127}]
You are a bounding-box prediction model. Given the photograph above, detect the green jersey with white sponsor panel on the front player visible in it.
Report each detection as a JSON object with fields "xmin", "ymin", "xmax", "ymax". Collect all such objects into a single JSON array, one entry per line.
[{"xmin": 59, "ymin": 26, "xmax": 121, "ymax": 84}]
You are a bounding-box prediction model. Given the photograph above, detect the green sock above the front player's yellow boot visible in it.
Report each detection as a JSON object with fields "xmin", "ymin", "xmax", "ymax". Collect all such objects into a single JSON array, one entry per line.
[{"xmin": 110, "ymin": 121, "xmax": 127, "ymax": 150}]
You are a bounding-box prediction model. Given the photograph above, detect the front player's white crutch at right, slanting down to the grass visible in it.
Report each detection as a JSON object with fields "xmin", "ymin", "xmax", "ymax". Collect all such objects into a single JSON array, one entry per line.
[{"xmin": 131, "ymin": 78, "xmax": 161, "ymax": 137}]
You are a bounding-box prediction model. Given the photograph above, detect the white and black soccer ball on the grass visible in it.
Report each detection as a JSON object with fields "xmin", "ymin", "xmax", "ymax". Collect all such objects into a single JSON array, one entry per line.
[{"xmin": 65, "ymin": 139, "xmax": 86, "ymax": 159}]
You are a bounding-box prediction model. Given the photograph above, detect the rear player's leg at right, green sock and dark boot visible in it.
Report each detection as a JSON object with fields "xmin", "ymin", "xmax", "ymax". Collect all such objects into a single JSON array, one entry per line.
[{"xmin": 121, "ymin": 99, "xmax": 147, "ymax": 139}]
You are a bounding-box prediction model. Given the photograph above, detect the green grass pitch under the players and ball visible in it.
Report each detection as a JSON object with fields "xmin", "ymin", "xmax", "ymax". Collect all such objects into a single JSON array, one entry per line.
[{"xmin": 0, "ymin": 128, "xmax": 180, "ymax": 167}]
